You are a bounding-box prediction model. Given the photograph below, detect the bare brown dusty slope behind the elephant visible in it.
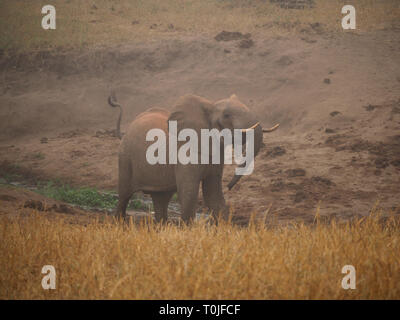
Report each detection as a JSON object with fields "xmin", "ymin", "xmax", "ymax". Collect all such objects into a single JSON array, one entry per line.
[{"xmin": 0, "ymin": 26, "xmax": 400, "ymax": 222}]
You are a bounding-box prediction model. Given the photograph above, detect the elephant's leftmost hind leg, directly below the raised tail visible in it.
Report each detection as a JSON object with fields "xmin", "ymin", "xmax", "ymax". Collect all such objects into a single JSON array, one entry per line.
[{"xmin": 116, "ymin": 158, "xmax": 133, "ymax": 219}]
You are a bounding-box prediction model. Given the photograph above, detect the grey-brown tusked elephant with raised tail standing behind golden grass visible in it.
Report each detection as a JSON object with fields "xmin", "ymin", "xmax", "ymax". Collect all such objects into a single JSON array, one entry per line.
[{"xmin": 108, "ymin": 94, "xmax": 279, "ymax": 224}]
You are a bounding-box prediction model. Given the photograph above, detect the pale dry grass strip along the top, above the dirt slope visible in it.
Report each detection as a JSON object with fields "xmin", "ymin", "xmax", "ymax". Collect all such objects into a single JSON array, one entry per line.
[{"xmin": 0, "ymin": 0, "xmax": 400, "ymax": 52}]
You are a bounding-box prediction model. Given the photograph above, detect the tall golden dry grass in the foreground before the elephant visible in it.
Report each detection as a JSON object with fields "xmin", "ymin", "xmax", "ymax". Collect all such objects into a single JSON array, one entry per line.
[{"xmin": 0, "ymin": 208, "xmax": 400, "ymax": 299}]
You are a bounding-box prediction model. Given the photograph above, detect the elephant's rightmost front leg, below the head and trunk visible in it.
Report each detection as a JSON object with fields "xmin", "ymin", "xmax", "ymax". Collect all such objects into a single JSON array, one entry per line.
[{"xmin": 202, "ymin": 175, "xmax": 228, "ymax": 219}]
